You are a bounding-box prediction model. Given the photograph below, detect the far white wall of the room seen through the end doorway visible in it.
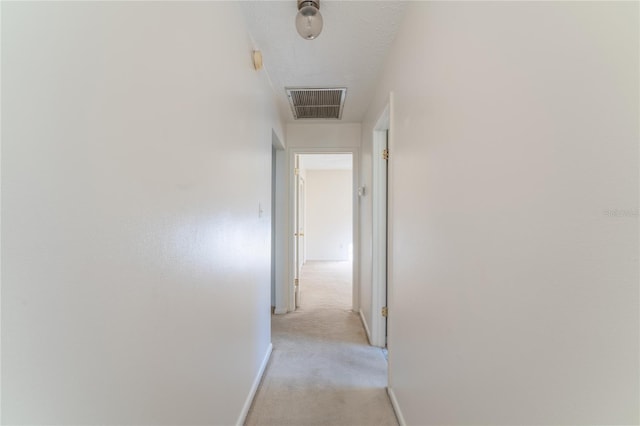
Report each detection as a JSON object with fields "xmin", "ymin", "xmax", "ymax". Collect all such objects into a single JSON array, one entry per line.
[{"xmin": 305, "ymin": 170, "xmax": 353, "ymax": 260}]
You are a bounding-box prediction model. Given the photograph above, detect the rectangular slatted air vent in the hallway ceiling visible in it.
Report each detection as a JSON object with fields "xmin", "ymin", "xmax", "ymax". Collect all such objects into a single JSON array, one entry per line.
[{"xmin": 285, "ymin": 87, "xmax": 347, "ymax": 120}]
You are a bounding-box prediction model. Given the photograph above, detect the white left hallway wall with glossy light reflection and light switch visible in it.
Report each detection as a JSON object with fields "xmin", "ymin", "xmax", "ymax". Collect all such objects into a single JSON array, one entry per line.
[{"xmin": 2, "ymin": 2, "xmax": 282, "ymax": 425}]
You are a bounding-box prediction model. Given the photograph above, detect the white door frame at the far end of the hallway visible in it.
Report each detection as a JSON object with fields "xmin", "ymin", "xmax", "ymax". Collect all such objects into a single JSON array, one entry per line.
[{"xmin": 285, "ymin": 147, "xmax": 360, "ymax": 312}]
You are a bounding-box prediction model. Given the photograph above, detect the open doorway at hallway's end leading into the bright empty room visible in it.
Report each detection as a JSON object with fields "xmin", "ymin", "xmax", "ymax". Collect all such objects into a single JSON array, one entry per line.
[{"xmin": 293, "ymin": 153, "xmax": 354, "ymax": 308}]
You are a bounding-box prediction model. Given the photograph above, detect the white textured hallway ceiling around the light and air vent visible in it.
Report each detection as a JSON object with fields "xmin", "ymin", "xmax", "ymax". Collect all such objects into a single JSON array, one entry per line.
[{"xmin": 242, "ymin": 0, "xmax": 407, "ymax": 122}]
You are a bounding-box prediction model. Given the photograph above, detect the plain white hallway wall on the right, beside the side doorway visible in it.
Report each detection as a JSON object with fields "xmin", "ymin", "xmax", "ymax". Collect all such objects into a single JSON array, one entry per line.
[{"xmin": 363, "ymin": 2, "xmax": 640, "ymax": 425}]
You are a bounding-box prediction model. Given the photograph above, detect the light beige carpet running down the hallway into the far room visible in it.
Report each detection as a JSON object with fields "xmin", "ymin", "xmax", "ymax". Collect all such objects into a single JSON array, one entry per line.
[{"xmin": 245, "ymin": 262, "xmax": 398, "ymax": 426}]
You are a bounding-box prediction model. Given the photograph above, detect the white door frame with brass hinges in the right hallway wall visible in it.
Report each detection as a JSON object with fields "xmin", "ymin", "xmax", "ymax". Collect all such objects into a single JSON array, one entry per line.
[{"xmin": 371, "ymin": 101, "xmax": 391, "ymax": 348}]
